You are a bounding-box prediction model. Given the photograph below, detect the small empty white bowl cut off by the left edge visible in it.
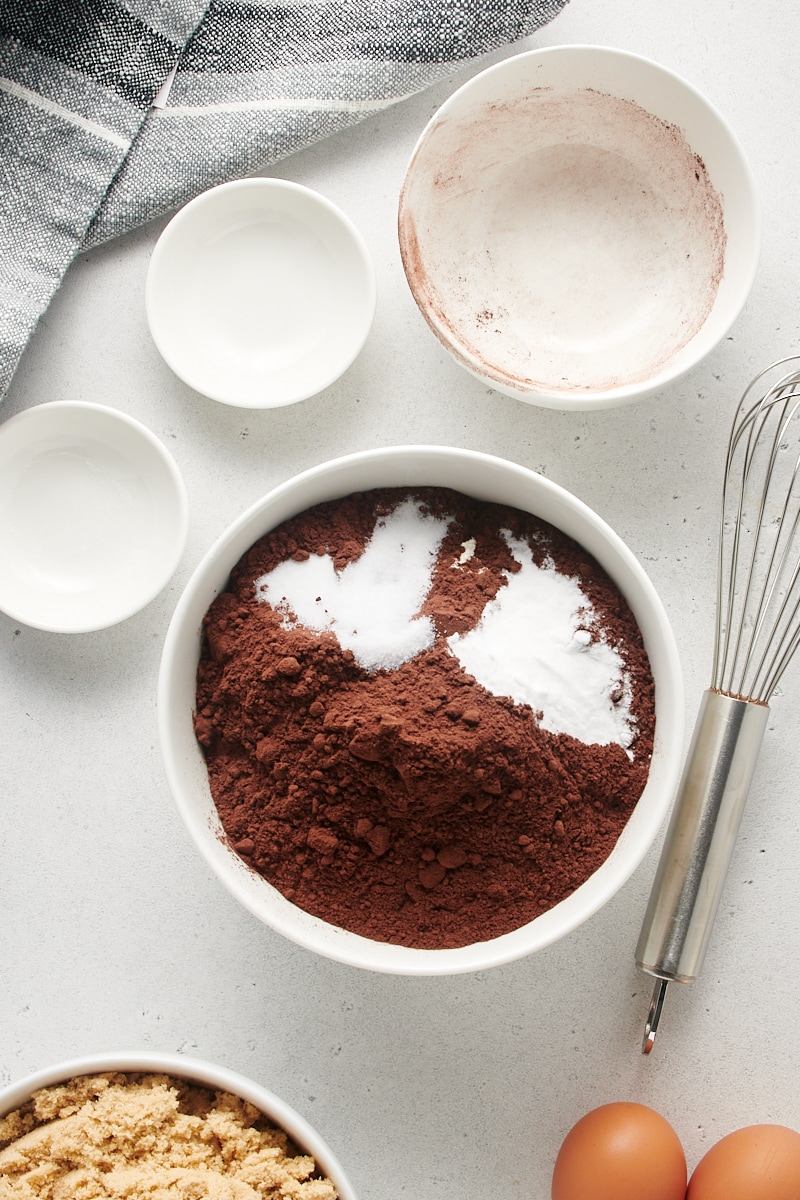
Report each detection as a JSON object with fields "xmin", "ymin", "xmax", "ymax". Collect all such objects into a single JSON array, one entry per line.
[{"xmin": 0, "ymin": 401, "xmax": 188, "ymax": 634}]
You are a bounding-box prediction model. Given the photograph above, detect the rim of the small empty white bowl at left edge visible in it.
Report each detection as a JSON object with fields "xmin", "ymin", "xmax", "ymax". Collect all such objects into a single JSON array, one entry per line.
[{"xmin": 0, "ymin": 400, "xmax": 190, "ymax": 634}]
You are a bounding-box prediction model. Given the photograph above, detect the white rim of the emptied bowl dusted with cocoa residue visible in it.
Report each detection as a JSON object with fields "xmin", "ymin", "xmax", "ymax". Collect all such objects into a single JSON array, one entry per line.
[{"xmin": 397, "ymin": 42, "xmax": 763, "ymax": 412}]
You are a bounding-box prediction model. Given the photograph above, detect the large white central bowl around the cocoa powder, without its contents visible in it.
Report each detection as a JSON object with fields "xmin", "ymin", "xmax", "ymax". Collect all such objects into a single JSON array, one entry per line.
[{"xmin": 158, "ymin": 446, "xmax": 684, "ymax": 976}]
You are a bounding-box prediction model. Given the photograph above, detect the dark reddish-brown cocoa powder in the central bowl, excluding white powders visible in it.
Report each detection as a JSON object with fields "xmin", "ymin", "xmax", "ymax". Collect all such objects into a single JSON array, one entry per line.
[{"xmin": 194, "ymin": 488, "xmax": 655, "ymax": 949}]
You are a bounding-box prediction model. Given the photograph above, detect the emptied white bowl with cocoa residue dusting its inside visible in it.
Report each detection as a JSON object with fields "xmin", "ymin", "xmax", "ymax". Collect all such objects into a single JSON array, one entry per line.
[{"xmin": 398, "ymin": 46, "xmax": 760, "ymax": 409}]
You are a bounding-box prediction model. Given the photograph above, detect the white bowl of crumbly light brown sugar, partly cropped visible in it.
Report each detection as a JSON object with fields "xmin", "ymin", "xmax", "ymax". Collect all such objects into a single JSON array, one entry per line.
[{"xmin": 0, "ymin": 1051, "xmax": 355, "ymax": 1200}]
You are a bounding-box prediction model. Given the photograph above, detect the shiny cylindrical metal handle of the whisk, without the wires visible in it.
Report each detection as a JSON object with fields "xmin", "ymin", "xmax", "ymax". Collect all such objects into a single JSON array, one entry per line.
[{"xmin": 636, "ymin": 689, "xmax": 769, "ymax": 1052}]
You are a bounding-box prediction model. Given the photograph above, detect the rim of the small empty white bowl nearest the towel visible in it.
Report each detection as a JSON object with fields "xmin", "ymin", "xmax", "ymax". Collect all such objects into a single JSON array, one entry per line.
[{"xmin": 144, "ymin": 175, "xmax": 378, "ymax": 409}]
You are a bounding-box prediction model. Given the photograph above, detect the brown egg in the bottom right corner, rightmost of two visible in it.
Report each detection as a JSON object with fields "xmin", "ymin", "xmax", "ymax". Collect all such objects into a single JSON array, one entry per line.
[{"xmin": 686, "ymin": 1124, "xmax": 800, "ymax": 1200}]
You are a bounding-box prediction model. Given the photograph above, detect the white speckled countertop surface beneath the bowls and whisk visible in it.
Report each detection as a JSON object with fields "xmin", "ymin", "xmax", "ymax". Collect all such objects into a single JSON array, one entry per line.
[{"xmin": 0, "ymin": 0, "xmax": 800, "ymax": 1200}]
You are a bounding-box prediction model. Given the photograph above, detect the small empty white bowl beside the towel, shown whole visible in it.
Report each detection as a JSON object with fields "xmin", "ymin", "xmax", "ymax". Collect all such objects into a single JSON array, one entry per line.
[{"xmin": 145, "ymin": 179, "xmax": 375, "ymax": 408}]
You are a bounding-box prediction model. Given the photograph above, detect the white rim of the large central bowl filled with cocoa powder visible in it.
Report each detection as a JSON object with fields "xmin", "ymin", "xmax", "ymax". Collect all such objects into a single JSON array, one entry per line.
[{"xmin": 157, "ymin": 445, "xmax": 685, "ymax": 976}]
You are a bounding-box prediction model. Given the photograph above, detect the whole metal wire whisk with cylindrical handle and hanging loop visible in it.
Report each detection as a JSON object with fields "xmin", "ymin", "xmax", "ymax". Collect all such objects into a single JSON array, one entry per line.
[{"xmin": 636, "ymin": 359, "xmax": 800, "ymax": 1054}]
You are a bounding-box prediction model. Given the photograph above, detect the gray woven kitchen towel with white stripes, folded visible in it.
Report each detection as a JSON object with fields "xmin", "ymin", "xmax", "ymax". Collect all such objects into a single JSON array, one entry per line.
[{"xmin": 0, "ymin": 0, "xmax": 567, "ymax": 396}]
